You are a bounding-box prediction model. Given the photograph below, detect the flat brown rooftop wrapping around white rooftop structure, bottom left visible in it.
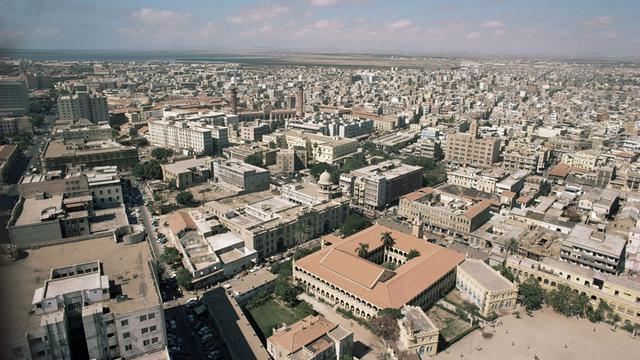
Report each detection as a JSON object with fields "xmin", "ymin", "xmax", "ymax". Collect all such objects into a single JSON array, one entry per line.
[{"xmin": 0, "ymin": 236, "xmax": 160, "ymax": 339}]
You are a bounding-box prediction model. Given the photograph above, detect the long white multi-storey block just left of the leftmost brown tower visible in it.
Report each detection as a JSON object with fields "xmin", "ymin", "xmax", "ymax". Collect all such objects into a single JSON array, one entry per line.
[{"xmin": 148, "ymin": 120, "xmax": 229, "ymax": 154}]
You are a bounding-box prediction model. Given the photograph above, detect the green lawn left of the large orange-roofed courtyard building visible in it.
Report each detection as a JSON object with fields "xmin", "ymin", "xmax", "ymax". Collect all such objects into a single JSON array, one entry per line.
[{"xmin": 249, "ymin": 299, "xmax": 311, "ymax": 338}]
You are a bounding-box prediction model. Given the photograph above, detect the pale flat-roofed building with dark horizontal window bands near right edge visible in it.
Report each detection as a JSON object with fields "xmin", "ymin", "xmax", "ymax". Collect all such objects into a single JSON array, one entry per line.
[{"xmin": 560, "ymin": 224, "xmax": 627, "ymax": 274}]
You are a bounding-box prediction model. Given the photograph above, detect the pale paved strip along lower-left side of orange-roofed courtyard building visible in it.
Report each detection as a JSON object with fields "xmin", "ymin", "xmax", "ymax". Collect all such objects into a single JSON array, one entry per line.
[{"xmin": 298, "ymin": 293, "xmax": 385, "ymax": 360}]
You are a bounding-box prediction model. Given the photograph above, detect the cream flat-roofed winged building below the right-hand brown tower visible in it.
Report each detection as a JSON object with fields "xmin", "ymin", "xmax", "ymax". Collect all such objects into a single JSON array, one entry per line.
[{"xmin": 262, "ymin": 130, "xmax": 359, "ymax": 164}]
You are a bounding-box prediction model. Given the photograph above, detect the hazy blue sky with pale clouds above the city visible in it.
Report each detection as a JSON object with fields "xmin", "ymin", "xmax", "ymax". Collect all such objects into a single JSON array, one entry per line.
[{"xmin": 0, "ymin": 0, "xmax": 640, "ymax": 59}]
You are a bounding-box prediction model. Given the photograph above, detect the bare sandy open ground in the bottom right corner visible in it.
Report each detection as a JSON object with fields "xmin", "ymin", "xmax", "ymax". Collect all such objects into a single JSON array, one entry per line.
[{"xmin": 435, "ymin": 309, "xmax": 640, "ymax": 360}]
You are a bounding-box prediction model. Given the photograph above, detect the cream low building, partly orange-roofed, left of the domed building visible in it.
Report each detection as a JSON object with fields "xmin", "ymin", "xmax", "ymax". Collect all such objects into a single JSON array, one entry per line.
[{"xmin": 168, "ymin": 210, "xmax": 258, "ymax": 287}]
